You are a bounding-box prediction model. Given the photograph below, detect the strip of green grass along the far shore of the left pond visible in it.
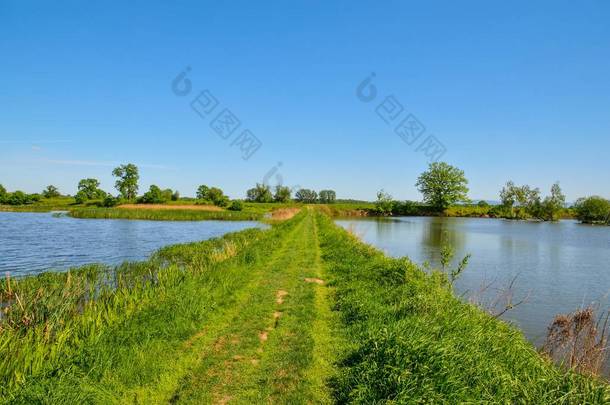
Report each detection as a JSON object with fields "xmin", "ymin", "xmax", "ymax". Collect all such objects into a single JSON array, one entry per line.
[{"xmin": 69, "ymin": 208, "xmax": 263, "ymax": 221}]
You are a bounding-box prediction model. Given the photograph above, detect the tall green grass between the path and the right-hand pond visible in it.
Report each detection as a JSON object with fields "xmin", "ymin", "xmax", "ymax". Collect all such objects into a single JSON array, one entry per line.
[{"xmin": 318, "ymin": 211, "xmax": 610, "ymax": 404}]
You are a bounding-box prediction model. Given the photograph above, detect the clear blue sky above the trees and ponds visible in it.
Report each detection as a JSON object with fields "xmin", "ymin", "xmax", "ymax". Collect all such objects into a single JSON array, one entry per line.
[{"xmin": 0, "ymin": 0, "xmax": 610, "ymax": 200}]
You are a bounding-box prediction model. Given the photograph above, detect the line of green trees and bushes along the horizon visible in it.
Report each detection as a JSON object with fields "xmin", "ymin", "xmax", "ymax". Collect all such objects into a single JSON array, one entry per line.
[{"xmin": 0, "ymin": 162, "xmax": 610, "ymax": 224}]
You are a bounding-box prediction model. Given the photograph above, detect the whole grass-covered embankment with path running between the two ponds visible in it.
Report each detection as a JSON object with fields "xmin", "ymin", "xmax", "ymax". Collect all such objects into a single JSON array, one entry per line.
[{"xmin": 0, "ymin": 210, "xmax": 610, "ymax": 404}]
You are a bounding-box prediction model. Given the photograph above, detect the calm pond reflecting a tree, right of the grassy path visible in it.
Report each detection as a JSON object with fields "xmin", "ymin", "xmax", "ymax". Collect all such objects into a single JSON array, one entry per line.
[{"xmin": 337, "ymin": 217, "xmax": 610, "ymax": 344}]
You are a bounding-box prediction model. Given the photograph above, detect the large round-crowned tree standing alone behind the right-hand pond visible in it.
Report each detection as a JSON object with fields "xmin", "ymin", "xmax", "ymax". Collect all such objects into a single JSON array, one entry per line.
[{"xmin": 415, "ymin": 162, "xmax": 468, "ymax": 211}]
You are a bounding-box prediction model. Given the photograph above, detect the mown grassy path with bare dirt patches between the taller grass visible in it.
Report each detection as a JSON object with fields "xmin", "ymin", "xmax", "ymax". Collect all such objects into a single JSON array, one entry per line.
[{"xmin": 166, "ymin": 210, "xmax": 328, "ymax": 403}]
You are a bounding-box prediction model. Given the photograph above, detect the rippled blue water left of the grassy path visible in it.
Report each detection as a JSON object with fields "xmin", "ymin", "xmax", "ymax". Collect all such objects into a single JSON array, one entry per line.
[{"xmin": 0, "ymin": 212, "xmax": 263, "ymax": 275}]
